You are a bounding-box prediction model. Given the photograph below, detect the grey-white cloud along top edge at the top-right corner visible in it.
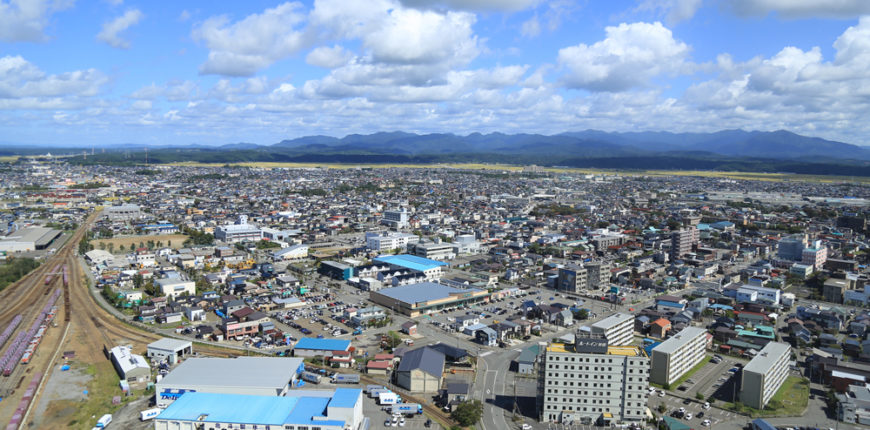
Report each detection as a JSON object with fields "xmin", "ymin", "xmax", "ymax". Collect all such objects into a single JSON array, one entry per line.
[{"xmin": 726, "ymin": 0, "xmax": 870, "ymax": 18}]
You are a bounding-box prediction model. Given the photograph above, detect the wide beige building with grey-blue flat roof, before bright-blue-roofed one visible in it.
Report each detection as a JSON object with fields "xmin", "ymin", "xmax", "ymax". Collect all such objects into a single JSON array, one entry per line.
[{"xmin": 369, "ymin": 282, "xmax": 489, "ymax": 318}]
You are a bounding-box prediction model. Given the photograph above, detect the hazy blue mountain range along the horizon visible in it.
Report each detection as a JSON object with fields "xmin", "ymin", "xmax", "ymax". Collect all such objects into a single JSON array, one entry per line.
[{"xmin": 35, "ymin": 130, "xmax": 870, "ymax": 176}]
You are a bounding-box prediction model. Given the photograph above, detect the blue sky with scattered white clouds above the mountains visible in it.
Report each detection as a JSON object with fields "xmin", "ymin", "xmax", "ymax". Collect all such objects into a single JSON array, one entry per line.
[{"xmin": 0, "ymin": 0, "xmax": 870, "ymax": 146}]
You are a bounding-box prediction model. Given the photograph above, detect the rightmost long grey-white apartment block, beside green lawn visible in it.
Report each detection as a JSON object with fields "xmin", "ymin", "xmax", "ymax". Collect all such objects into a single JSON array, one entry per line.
[{"xmin": 740, "ymin": 342, "xmax": 791, "ymax": 409}]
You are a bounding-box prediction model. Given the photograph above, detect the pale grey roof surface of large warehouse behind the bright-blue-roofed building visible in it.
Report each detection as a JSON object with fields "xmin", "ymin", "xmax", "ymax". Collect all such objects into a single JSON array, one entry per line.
[{"xmin": 160, "ymin": 357, "xmax": 302, "ymax": 391}]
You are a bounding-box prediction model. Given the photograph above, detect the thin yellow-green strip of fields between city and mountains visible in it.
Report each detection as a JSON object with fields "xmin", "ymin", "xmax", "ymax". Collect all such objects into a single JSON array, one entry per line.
[{"xmin": 160, "ymin": 162, "xmax": 870, "ymax": 183}]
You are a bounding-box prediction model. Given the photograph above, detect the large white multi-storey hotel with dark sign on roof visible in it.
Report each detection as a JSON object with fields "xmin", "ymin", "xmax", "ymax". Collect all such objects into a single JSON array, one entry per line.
[{"xmin": 540, "ymin": 333, "xmax": 649, "ymax": 425}]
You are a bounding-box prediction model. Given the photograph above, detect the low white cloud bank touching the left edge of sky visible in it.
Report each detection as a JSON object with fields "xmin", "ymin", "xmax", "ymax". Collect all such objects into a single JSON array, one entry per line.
[{"xmin": 0, "ymin": 56, "xmax": 107, "ymax": 109}]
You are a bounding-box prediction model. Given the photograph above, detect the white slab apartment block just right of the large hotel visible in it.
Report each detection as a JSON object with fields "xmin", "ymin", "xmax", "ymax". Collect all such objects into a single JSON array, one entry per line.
[{"xmin": 650, "ymin": 327, "xmax": 707, "ymax": 385}]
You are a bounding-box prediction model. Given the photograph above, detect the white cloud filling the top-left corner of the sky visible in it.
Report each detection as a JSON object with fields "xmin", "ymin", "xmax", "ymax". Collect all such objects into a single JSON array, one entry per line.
[{"xmin": 0, "ymin": 0, "xmax": 72, "ymax": 42}]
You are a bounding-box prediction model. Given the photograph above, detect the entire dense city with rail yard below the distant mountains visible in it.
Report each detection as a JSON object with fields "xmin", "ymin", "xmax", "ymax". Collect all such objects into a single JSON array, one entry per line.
[{"xmin": 0, "ymin": 156, "xmax": 870, "ymax": 430}]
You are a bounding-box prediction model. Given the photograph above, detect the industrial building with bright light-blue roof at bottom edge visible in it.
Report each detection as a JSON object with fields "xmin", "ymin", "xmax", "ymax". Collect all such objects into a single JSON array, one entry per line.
[{"xmin": 154, "ymin": 388, "xmax": 365, "ymax": 430}]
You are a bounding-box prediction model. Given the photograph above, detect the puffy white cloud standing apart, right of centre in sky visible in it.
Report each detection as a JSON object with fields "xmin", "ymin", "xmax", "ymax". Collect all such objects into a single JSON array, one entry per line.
[{"xmin": 559, "ymin": 22, "xmax": 689, "ymax": 91}]
